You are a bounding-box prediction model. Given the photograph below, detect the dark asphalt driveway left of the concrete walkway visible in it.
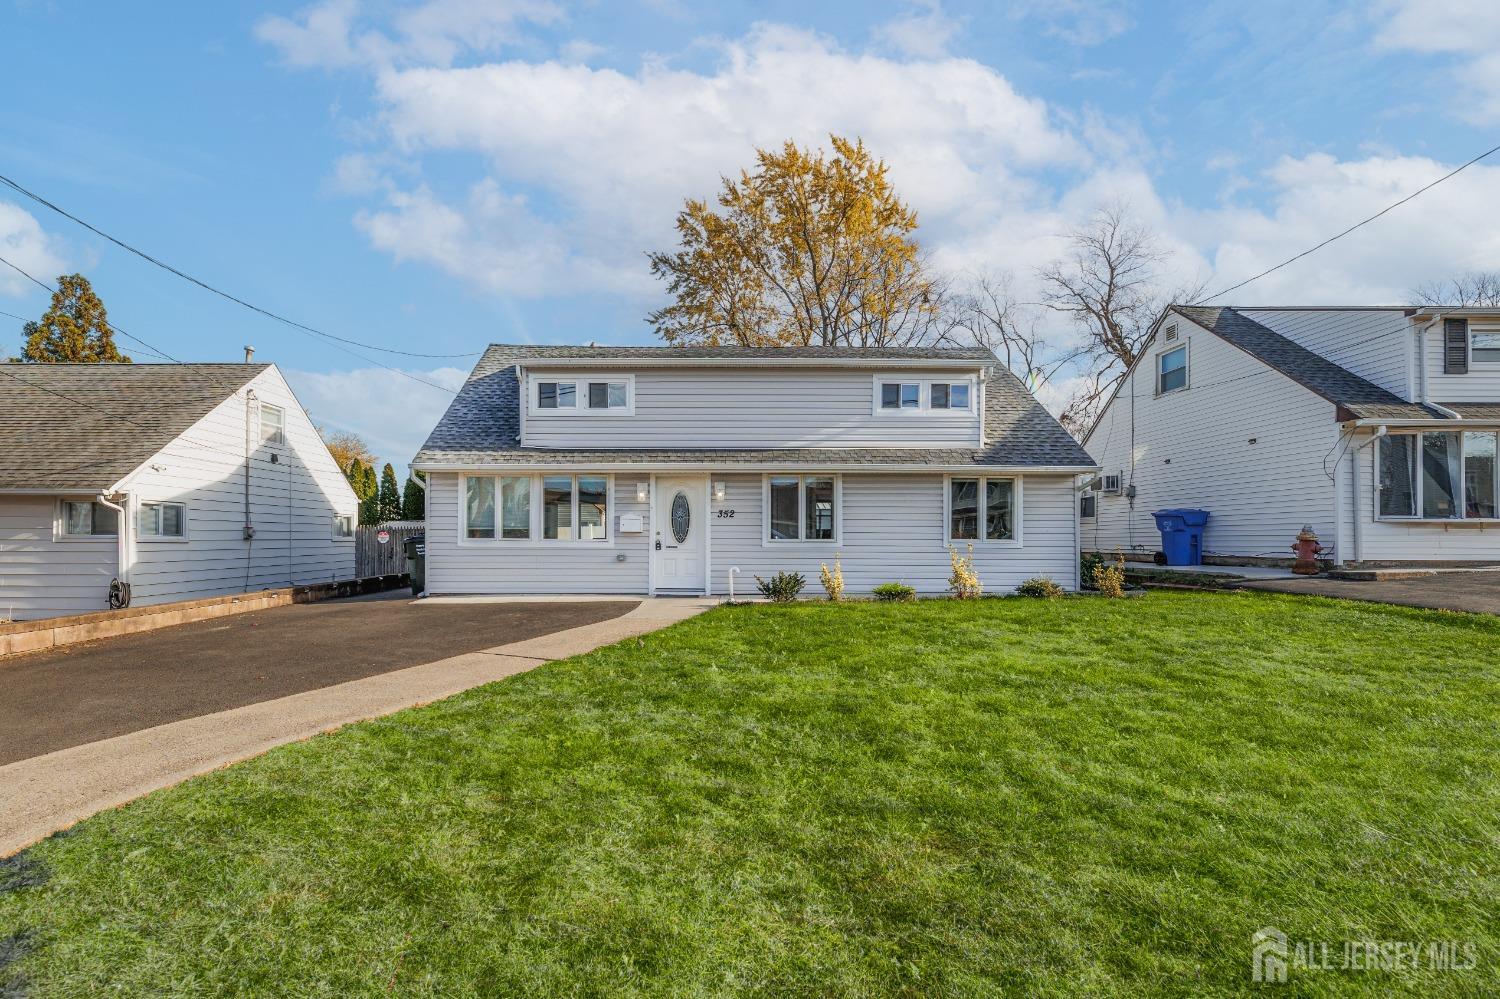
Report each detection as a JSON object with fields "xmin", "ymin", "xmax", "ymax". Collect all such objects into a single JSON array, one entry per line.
[{"xmin": 0, "ymin": 593, "xmax": 639, "ymax": 765}]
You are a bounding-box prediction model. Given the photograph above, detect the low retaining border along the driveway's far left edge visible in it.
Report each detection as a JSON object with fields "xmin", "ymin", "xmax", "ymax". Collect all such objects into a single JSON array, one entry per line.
[{"xmin": 0, "ymin": 573, "xmax": 410, "ymax": 663}]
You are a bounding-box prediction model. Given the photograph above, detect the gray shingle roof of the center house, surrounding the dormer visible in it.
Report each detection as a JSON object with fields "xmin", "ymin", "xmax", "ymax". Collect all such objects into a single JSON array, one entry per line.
[{"xmin": 416, "ymin": 344, "xmax": 1094, "ymax": 467}]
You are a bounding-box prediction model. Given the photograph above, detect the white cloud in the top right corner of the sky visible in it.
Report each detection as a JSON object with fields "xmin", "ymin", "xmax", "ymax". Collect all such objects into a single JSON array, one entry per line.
[{"xmin": 1376, "ymin": 0, "xmax": 1500, "ymax": 125}]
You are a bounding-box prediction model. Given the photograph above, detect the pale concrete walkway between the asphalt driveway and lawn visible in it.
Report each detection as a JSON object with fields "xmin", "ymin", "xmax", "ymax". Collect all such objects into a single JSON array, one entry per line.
[{"xmin": 0, "ymin": 599, "xmax": 717, "ymax": 857}]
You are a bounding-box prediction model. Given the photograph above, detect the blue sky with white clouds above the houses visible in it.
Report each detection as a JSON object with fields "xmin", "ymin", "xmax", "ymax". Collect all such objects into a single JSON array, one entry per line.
[{"xmin": 0, "ymin": 0, "xmax": 1500, "ymax": 464}]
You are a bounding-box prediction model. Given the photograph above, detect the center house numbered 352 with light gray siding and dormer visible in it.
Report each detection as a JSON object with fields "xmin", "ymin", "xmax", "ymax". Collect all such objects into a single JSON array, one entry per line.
[{"xmin": 414, "ymin": 345, "xmax": 1095, "ymax": 594}]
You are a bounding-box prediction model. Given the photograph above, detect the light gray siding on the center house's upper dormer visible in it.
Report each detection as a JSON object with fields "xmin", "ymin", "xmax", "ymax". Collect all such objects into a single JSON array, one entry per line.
[{"xmin": 522, "ymin": 368, "xmax": 980, "ymax": 450}]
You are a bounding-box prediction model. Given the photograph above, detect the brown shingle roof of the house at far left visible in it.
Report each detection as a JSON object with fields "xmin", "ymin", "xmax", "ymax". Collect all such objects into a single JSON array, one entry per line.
[{"xmin": 0, "ymin": 365, "xmax": 270, "ymax": 492}]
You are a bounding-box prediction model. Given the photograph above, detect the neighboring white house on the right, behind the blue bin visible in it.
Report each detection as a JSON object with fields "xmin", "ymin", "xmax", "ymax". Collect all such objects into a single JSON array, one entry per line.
[{"xmin": 1080, "ymin": 306, "xmax": 1500, "ymax": 563}]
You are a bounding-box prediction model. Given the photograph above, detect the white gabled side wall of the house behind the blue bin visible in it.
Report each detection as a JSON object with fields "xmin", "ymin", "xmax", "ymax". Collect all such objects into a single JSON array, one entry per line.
[{"xmin": 1082, "ymin": 318, "xmax": 1340, "ymax": 557}]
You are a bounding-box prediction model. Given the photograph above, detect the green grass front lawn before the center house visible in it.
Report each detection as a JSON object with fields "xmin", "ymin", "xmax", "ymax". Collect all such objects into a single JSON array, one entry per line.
[{"xmin": 0, "ymin": 593, "xmax": 1500, "ymax": 996}]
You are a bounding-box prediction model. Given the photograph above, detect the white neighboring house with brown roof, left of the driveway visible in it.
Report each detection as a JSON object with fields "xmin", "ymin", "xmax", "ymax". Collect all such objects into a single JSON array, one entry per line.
[{"xmin": 0, "ymin": 365, "xmax": 359, "ymax": 620}]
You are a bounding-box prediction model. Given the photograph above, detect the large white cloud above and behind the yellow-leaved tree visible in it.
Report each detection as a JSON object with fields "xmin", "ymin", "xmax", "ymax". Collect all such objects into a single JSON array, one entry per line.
[{"xmin": 360, "ymin": 26, "xmax": 1089, "ymax": 294}]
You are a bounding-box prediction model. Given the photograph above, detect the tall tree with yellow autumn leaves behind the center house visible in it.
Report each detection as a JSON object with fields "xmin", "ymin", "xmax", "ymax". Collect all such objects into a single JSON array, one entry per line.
[{"xmin": 648, "ymin": 135, "xmax": 944, "ymax": 347}]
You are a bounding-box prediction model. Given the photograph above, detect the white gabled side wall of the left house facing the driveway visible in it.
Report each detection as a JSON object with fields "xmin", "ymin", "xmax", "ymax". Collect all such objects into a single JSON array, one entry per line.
[{"xmin": 128, "ymin": 368, "xmax": 359, "ymax": 606}]
